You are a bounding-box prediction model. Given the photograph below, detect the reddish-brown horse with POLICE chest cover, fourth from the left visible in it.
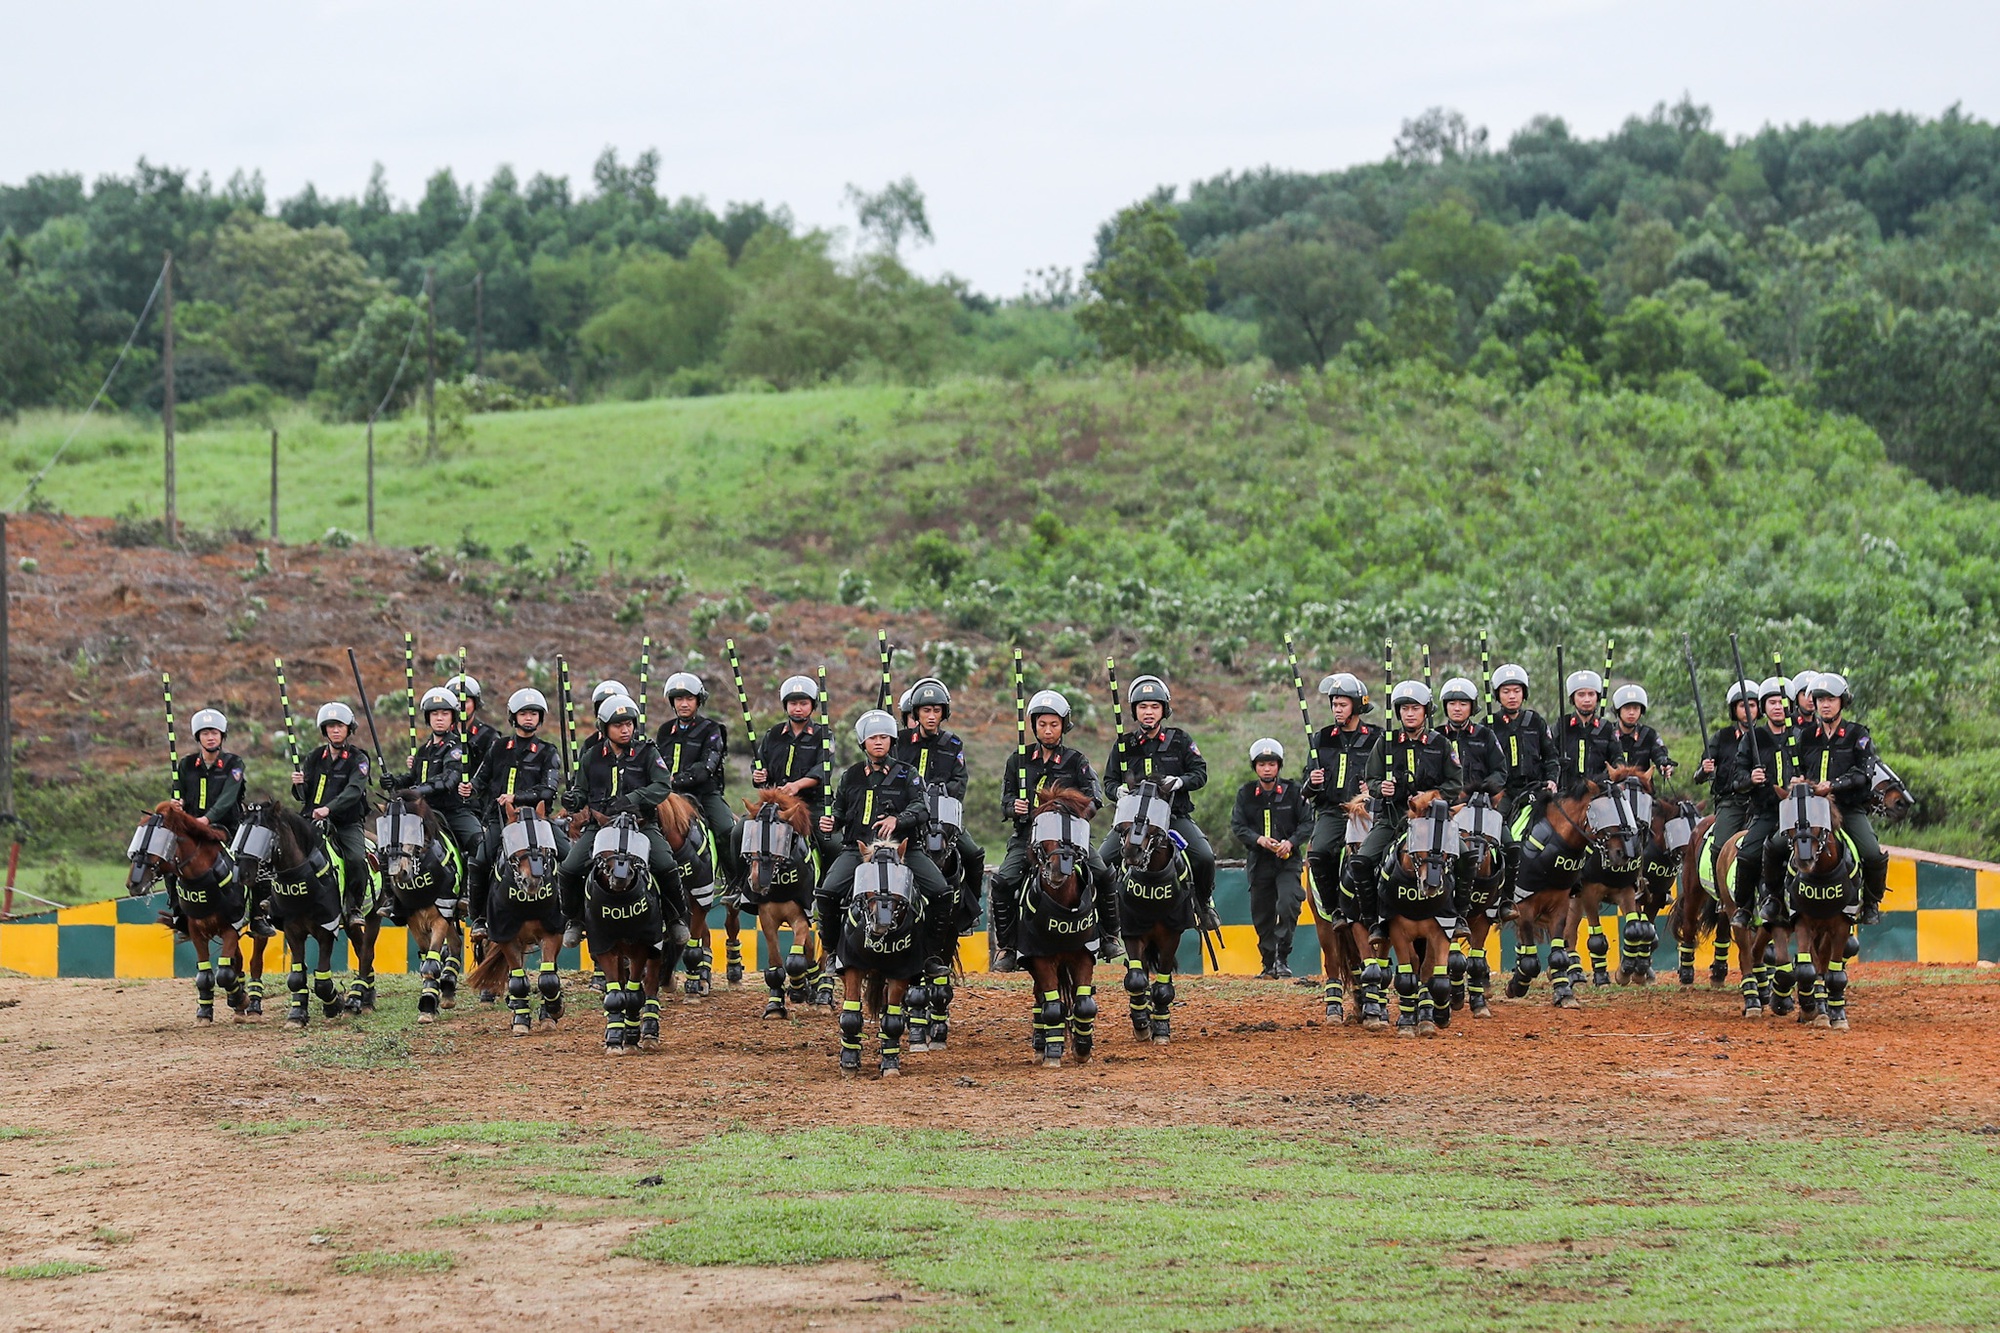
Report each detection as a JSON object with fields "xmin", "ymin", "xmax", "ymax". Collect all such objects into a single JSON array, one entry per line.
[{"xmin": 466, "ymin": 807, "xmax": 568, "ymax": 1037}]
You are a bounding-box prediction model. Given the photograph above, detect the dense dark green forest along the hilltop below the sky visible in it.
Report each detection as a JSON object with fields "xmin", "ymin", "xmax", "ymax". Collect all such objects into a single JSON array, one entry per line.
[{"xmin": 0, "ymin": 100, "xmax": 2000, "ymax": 490}]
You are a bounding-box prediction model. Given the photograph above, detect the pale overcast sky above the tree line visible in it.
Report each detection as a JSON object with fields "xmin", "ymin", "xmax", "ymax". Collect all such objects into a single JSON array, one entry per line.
[{"xmin": 0, "ymin": 0, "xmax": 2000, "ymax": 294}]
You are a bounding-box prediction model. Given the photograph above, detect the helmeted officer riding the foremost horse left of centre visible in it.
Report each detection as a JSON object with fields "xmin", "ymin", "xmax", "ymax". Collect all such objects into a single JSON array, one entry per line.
[{"xmin": 814, "ymin": 709, "xmax": 952, "ymax": 957}]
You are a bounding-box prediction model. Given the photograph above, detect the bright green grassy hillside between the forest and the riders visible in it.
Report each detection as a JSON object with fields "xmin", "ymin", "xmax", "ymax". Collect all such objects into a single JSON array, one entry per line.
[{"xmin": 0, "ymin": 368, "xmax": 2000, "ymax": 853}]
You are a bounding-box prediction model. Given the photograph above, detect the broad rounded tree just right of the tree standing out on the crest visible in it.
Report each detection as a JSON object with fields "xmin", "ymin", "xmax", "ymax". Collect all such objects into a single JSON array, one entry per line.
[{"xmin": 1216, "ymin": 222, "xmax": 1382, "ymax": 366}]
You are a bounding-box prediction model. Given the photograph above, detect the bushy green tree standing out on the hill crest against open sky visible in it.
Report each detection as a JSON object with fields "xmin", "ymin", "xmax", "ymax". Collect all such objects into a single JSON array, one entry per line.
[{"xmin": 1076, "ymin": 200, "xmax": 1222, "ymax": 368}]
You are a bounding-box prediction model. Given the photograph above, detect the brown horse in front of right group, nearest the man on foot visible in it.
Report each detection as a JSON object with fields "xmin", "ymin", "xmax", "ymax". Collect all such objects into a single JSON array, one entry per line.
[{"xmin": 1374, "ymin": 791, "xmax": 1460, "ymax": 1037}]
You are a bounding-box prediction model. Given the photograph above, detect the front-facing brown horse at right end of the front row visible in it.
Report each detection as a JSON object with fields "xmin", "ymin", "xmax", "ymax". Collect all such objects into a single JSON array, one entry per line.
[{"xmin": 1758, "ymin": 785, "xmax": 1862, "ymax": 1033}]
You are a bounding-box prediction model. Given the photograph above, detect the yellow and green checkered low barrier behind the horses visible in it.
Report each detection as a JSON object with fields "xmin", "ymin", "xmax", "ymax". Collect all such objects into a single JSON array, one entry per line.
[{"xmin": 0, "ymin": 847, "xmax": 2000, "ymax": 979}]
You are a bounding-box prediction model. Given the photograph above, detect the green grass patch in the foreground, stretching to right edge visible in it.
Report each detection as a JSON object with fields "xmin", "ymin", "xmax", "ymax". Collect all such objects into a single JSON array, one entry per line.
[{"xmin": 580, "ymin": 1129, "xmax": 2000, "ymax": 1333}]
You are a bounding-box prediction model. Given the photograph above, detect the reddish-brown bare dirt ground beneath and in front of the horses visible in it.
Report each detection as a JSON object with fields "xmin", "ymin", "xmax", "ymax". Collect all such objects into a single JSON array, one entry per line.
[{"xmin": 0, "ymin": 965, "xmax": 2000, "ymax": 1329}]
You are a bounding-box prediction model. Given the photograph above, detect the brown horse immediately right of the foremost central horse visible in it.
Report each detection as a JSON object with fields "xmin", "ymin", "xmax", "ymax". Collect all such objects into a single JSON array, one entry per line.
[{"xmin": 1018, "ymin": 787, "xmax": 1102, "ymax": 1069}]
